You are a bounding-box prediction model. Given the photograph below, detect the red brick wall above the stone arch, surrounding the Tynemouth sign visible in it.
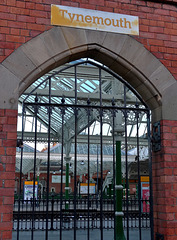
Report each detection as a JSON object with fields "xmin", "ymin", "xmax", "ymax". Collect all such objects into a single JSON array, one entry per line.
[{"xmin": 0, "ymin": 0, "xmax": 177, "ymax": 78}]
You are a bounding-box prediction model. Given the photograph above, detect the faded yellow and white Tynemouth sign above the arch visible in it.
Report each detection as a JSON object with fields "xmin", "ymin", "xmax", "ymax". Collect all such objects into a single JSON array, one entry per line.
[{"xmin": 51, "ymin": 4, "xmax": 139, "ymax": 35}]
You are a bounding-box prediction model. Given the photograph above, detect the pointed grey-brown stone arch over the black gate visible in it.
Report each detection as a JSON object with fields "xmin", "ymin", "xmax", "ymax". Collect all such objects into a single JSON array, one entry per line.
[{"xmin": 0, "ymin": 27, "xmax": 177, "ymax": 121}]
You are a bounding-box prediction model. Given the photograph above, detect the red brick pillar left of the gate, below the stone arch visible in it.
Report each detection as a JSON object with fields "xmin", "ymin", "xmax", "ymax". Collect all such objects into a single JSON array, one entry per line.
[{"xmin": 0, "ymin": 109, "xmax": 17, "ymax": 240}]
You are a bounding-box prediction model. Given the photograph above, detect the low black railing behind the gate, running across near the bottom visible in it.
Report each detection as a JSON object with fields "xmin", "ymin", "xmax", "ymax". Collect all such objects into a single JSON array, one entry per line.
[{"xmin": 13, "ymin": 198, "xmax": 150, "ymax": 230}]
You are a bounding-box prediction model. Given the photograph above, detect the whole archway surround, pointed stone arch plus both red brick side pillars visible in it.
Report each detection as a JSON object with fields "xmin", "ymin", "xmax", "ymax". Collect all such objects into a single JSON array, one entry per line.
[{"xmin": 0, "ymin": 27, "xmax": 177, "ymax": 239}]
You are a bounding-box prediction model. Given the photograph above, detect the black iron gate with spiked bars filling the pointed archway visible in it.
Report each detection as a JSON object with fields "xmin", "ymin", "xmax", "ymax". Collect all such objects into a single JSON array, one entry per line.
[{"xmin": 13, "ymin": 59, "xmax": 153, "ymax": 240}]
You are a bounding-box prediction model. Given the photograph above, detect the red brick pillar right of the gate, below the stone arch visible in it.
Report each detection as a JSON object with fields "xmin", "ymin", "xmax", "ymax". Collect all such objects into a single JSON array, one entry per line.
[{"xmin": 153, "ymin": 120, "xmax": 177, "ymax": 240}]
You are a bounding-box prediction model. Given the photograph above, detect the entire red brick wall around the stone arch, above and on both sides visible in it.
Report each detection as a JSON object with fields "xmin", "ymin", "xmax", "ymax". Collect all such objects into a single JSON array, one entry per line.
[{"xmin": 0, "ymin": 0, "xmax": 177, "ymax": 240}]
